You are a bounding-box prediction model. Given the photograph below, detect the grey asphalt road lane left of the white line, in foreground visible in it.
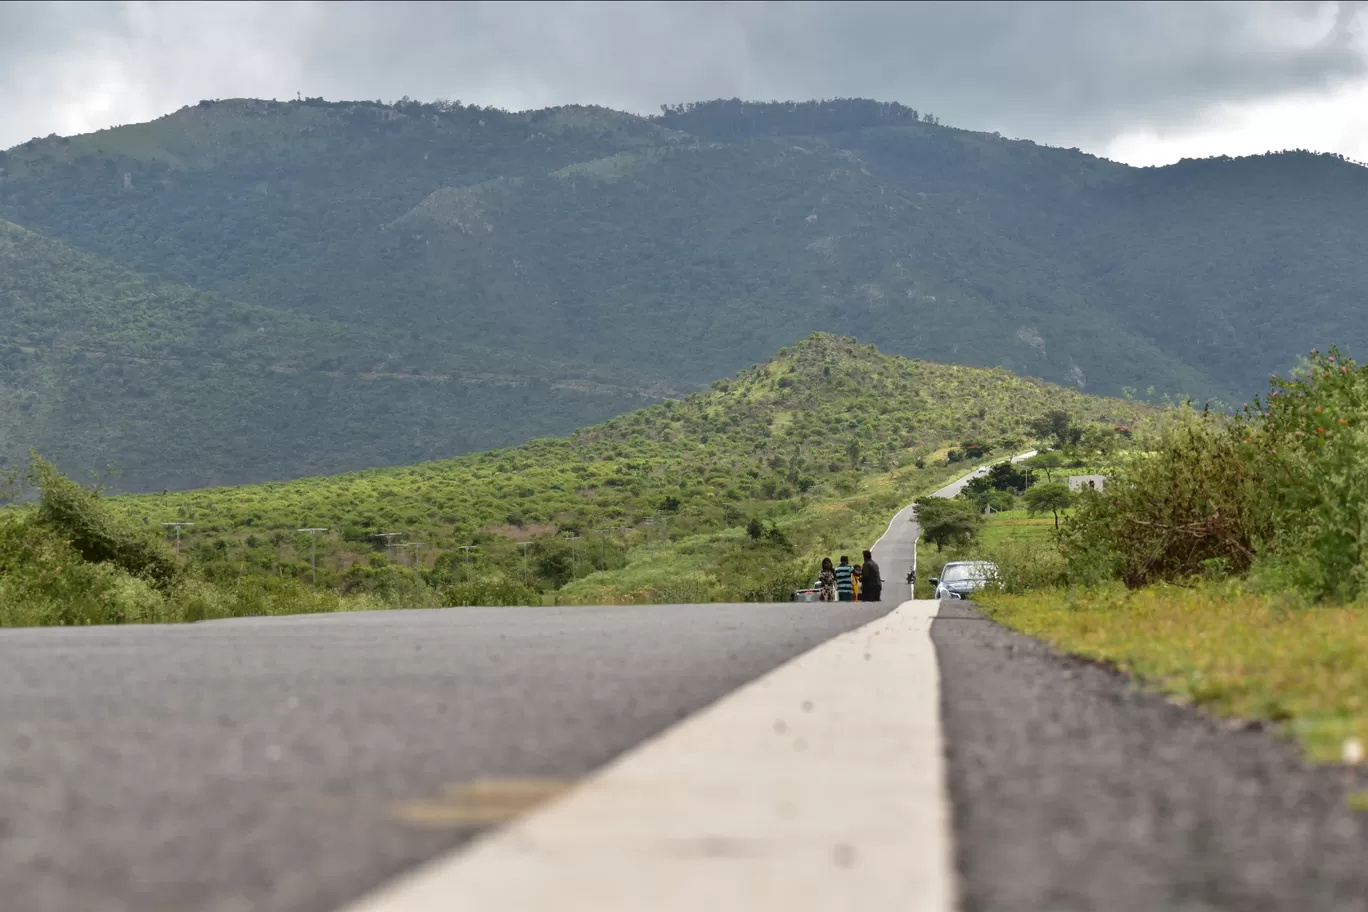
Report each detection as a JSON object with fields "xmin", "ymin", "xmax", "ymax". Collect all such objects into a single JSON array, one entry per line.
[{"xmin": 0, "ymin": 603, "xmax": 892, "ymax": 912}]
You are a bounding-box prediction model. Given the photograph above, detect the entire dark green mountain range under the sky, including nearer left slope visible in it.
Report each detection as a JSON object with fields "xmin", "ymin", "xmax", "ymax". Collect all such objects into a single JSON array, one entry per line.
[{"xmin": 0, "ymin": 100, "xmax": 1368, "ymax": 489}]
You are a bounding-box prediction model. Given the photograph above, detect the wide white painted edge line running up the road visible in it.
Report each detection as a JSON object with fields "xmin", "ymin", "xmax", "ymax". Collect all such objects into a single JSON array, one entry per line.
[{"xmin": 346, "ymin": 602, "xmax": 955, "ymax": 912}]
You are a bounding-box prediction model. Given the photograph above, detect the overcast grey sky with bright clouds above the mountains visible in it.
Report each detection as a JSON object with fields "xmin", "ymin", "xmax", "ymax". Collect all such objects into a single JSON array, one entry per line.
[{"xmin": 8, "ymin": 0, "xmax": 1368, "ymax": 164}]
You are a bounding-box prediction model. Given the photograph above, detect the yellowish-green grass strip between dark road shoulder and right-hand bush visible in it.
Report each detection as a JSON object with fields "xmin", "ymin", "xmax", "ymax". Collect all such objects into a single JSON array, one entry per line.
[{"xmin": 975, "ymin": 584, "xmax": 1368, "ymax": 763}]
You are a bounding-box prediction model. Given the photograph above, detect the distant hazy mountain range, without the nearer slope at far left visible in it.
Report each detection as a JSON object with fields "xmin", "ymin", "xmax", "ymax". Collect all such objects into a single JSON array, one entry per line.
[{"xmin": 0, "ymin": 100, "xmax": 1368, "ymax": 489}]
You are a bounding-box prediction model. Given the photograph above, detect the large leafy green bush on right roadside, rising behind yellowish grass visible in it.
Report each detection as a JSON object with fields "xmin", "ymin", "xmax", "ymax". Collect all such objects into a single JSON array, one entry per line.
[{"xmin": 1060, "ymin": 349, "xmax": 1368, "ymax": 600}]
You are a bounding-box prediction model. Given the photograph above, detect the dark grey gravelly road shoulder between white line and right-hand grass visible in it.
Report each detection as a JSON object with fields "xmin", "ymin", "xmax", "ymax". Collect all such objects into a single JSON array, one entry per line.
[{"xmin": 932, "ymin": 602, "xmax": 1368, "ymax": 912}]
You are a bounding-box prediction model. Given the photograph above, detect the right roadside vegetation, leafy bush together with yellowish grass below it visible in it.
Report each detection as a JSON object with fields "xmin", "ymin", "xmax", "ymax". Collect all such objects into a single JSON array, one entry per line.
[{"xmin": 981, "ymin": 350, "xmax": 1368, "ymax": 762}]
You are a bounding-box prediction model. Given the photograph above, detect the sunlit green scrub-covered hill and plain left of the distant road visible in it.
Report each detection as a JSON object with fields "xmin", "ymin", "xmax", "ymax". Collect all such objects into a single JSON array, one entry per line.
[{"xmin": 0, "ymin": 334, "xmax": 1157, "ymax": 623}]
